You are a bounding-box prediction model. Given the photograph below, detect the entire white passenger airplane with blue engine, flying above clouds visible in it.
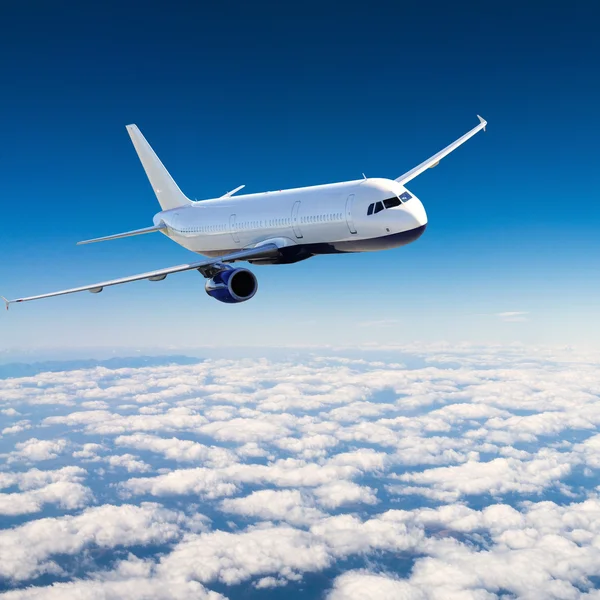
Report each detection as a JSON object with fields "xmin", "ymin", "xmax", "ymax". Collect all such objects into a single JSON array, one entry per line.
[{"xmin": 1, "ymin": 115, "xmax": 487, "ymax": 310}]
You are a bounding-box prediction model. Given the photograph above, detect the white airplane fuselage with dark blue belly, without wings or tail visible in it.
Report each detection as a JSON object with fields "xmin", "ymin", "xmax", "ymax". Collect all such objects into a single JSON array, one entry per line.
[{"xmin": 154, "ymin": 178, "xmax": 427, "ymax": 264}]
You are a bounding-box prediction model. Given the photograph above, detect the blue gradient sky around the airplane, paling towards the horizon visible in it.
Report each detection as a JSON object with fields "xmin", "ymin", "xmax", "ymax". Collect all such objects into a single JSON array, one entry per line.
[{"xmin": 0, "ymin": 1, "xmax": 600, "ymax": 352}]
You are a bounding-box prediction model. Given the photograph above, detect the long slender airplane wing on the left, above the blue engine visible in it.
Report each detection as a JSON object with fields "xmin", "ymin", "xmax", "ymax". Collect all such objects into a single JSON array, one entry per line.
[{"xmin": 0, "ymin": 244, "xmax": 279, "ymax": 310}]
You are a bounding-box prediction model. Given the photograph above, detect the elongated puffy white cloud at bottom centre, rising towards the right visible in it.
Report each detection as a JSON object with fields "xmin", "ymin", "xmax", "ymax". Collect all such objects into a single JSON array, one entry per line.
[{"xmin": 157, "ymin": 514, "xmax": 423, "ymax": 585}]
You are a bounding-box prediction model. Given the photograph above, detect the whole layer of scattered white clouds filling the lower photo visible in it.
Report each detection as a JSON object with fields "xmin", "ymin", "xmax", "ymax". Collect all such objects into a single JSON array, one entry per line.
[{"xmin": 5, "ymin": 344, "xmax": 600, "ymax": 600}]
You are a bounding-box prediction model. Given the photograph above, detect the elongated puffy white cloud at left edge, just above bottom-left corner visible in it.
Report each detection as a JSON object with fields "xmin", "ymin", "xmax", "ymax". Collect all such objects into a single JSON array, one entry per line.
[{"xmin": 0, "ymin": 504, "xmax": 190, "ymax": 580}]
